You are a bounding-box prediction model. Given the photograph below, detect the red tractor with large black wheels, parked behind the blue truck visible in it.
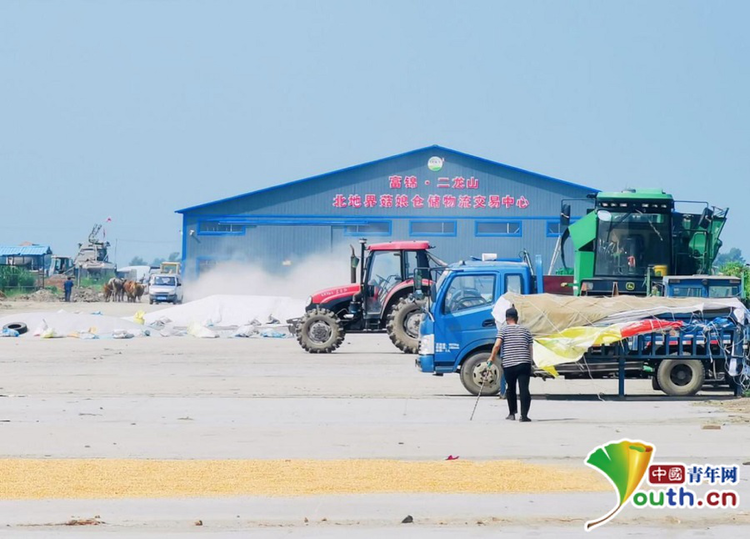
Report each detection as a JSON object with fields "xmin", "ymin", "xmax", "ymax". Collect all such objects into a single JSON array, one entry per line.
[{"xmin": 290, "ymin": 240, "xmax": 445, "ymax": 354}]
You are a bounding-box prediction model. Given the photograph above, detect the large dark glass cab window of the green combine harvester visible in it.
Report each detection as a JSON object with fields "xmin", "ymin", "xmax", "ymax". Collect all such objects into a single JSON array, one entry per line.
[{"xmin": 595, "ymin": 211, "xmax": 670, "ymax": 277}]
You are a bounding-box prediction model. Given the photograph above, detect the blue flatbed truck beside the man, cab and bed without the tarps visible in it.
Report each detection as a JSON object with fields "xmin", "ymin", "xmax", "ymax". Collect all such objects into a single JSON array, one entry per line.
[{"xmin": 416, "ymin": 259, "xmax": 750, "ymax": 396}]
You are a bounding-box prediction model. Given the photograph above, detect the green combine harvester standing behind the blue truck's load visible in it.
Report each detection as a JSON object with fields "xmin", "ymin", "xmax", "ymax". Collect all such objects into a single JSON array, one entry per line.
[{"xmin": 560, "ymin": 189, "xmax": 728, "ymax": 296}]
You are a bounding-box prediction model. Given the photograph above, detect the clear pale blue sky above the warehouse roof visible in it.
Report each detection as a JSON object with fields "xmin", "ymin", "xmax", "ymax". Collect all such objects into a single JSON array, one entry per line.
[{"xmin": 0, "ymin": 0, "xmax": 750, "ymax": 264}]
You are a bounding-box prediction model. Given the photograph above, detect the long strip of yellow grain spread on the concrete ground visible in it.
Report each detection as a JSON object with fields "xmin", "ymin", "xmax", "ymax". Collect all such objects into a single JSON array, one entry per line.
[{"xmin": 0, "ymin": 459, "xmax": 611, "ymax": 500}]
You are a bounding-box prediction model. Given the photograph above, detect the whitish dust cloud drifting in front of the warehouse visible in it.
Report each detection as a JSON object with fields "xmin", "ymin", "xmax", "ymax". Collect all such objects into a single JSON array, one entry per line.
[{"xmin": 185, "ymin": 254, "xmax": 350, "ymax": 301}]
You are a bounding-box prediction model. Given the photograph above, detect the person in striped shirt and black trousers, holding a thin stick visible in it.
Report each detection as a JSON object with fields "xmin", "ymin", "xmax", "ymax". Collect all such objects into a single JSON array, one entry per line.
[{"xmin": 487, "ymin": 307, "xmax": 534, "ymax": 422}]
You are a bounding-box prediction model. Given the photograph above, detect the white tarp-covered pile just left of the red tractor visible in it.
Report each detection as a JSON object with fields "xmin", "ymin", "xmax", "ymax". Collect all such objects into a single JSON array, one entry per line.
[{"xmin": 145, "ymin": 295, "xmax": 305, "ymax": 328}]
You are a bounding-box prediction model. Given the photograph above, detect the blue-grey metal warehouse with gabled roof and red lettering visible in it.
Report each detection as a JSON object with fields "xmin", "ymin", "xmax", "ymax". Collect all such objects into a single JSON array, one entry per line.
[{"xmin": 178, "ymin": 146, "xmax": 595, "ymax": 279}]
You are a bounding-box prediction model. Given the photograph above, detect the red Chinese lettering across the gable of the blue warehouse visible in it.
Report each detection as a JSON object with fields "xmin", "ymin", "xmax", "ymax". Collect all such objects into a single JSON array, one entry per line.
[{"xmin": 333, "ymin": 176, "xmax": 530, "ymax": 210}]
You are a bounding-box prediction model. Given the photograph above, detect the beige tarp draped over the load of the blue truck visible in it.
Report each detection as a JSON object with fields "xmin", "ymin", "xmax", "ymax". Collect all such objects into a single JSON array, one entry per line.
[{"xmin": 492, "ymin": 293, "xmax": 748, "ymax": 337}]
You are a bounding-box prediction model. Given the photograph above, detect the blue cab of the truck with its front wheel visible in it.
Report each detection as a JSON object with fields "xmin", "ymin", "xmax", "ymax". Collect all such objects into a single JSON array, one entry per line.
[{"xmin": 416, "ymin": 261, "xmax": 535, "ymax": 395}]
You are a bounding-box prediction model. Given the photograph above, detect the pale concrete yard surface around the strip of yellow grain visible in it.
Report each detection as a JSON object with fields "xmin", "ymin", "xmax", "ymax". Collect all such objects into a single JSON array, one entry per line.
[{"xmin": 0, "ymin": 304, "xmax": 750, "ymax": 538}]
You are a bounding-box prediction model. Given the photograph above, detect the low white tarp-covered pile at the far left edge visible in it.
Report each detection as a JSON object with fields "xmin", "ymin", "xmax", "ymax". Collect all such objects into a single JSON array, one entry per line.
[{"xmin": 0, "ymin": 310, "xmax": 144, "ymax": 338}]
